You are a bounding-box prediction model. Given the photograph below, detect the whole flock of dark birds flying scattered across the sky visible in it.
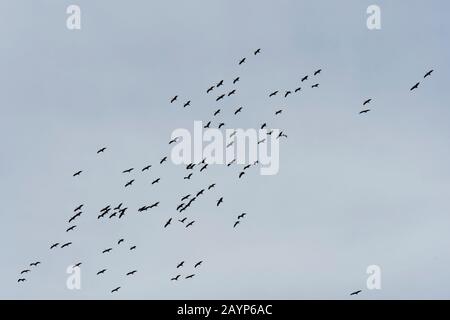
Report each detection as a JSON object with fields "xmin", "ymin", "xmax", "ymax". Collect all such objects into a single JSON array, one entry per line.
[{"xmin": 17, "ymin": 49, "xmax": 433, "ymax": 295}]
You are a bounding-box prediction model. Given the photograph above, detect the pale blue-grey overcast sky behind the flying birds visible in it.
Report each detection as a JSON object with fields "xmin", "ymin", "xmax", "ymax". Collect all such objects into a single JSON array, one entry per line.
[{"xmin": 0, "ymin": 0, "xmax": 450, "ymax": 299}]
